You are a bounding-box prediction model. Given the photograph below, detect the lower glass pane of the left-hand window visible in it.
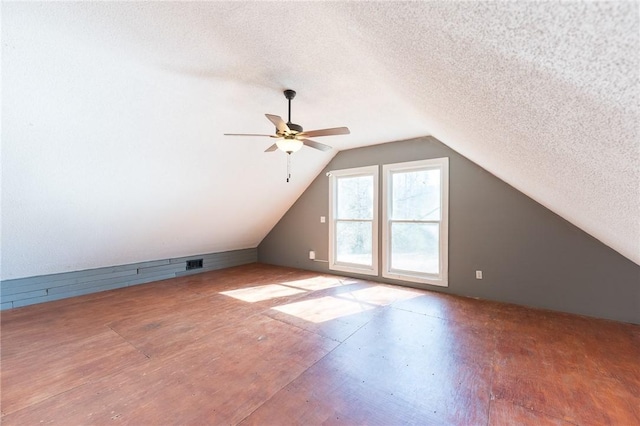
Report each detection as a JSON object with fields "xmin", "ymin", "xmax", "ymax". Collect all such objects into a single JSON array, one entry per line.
[{"xmin": 336, "ymin": 221, "xmax": 373, "ymax": 266}]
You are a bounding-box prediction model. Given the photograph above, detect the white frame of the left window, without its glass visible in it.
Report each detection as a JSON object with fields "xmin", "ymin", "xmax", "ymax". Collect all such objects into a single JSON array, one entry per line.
[{"xmin": 329, "ymin": 165, "xmax": 379, "ymax": 276}]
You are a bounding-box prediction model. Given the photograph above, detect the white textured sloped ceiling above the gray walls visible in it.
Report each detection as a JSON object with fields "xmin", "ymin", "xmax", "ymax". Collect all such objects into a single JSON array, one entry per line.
[{"xmin": 2, "ymin": 2, "xmax": 640, "ymax": 279}]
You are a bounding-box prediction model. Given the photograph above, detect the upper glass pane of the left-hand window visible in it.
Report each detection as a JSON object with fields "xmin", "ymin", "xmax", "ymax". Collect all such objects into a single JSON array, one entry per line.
[{"xmin": 337, "ymin": 176, "xmax": 373, "ymax": 220}]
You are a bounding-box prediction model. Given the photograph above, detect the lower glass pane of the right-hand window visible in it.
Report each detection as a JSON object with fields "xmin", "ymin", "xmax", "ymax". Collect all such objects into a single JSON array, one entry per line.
[{"xmin": 391, "ymin": 222, "xmax": 440, "ymax": 274}]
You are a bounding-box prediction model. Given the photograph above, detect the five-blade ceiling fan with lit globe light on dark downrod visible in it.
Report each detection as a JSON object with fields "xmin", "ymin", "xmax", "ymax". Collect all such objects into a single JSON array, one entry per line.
[{"xmin": 225, "ymin": 89, "xmax": 351, "ymax": 154}]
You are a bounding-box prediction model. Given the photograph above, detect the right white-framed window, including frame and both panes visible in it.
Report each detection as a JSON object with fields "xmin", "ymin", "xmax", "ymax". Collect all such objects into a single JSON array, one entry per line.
[{"xmin": 382, "ymin": 158, "xmax": 449, "ymax": 286}]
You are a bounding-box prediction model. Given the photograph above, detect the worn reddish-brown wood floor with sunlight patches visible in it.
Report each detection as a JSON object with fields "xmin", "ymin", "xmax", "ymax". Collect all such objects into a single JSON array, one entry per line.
[{"xmin": 0, "ymin": 264, "xmax": 640, "ymax": 425}]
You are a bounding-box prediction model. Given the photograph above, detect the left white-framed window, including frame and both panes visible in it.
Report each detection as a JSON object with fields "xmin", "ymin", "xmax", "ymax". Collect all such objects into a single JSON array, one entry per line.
[{"xmin": 329, "ymin": 166, "xmax": 378, "ymax": 275}]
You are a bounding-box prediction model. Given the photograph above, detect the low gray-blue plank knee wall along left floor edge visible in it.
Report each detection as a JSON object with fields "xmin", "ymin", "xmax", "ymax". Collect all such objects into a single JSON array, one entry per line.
[{"xmin": 0, "ymin": 248, "xmax": 258, "ymax": 310}]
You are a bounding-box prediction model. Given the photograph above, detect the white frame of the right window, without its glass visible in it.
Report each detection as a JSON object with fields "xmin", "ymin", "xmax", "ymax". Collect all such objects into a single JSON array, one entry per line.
[{"xmin": 382, "ymin": 157, "xmax": 449, "ymax": 287}]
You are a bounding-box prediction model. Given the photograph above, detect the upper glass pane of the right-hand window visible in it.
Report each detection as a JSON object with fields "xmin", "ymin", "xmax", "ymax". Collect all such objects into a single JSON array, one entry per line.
[{"xmin": 391, "ymin": 169, "xmax": 440, "ymax": 220}]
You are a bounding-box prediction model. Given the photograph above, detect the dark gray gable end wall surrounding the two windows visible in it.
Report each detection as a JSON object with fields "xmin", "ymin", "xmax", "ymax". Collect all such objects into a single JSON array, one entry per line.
[{"xmin": 258, "ymin": 137, "xmax": 640, "ymax": 324}]
